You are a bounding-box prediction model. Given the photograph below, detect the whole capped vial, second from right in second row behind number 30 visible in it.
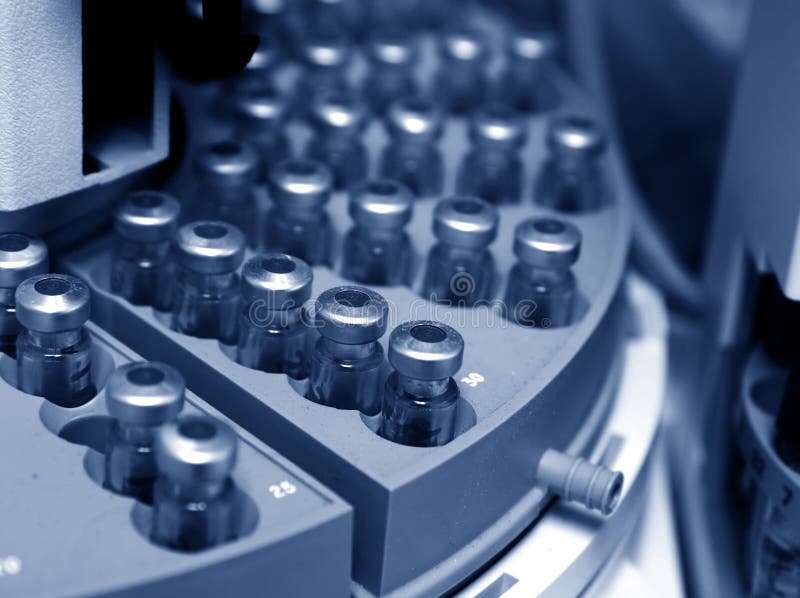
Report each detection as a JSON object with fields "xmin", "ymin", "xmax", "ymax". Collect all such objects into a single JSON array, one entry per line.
[{"xmin": 423, "ymin": 196, "xmax": 499, "ymax": 307}]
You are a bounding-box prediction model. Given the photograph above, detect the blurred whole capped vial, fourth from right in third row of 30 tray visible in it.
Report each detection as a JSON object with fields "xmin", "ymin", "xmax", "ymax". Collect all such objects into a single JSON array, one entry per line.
[{"xmin": 306, "ymin": 91, "xmax": 368, "ymax": 189}]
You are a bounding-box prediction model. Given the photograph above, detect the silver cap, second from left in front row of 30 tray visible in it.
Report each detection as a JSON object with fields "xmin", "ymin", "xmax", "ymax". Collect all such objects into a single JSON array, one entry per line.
[{"xmin": 175, "ymin": 220, "xmax": 245, "ymax": 274}]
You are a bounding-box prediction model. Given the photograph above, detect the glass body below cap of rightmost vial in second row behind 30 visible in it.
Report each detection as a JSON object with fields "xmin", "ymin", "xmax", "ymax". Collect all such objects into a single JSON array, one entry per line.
[{"xmin": 506, "ymin": 263, "xmax": 577, "ymax": 328}]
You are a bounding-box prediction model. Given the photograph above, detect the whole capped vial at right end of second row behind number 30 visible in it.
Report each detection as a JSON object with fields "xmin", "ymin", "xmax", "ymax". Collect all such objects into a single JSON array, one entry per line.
[{"xmin": 506, "ymin": 218, "xmax": 581, "ymax": 328}]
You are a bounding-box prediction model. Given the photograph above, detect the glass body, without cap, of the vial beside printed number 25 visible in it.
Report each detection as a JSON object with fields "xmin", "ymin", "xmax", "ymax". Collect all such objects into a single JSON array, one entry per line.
[{"xmin": 150, "ymin": 476, "xmax": 236, "ymax": 551}]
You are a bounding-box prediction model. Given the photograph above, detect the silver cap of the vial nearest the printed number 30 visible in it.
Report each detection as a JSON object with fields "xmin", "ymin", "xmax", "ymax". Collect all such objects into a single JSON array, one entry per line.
[{"xmin": 389, "ymin": 320, "xmax": 464, "ymax": 380}]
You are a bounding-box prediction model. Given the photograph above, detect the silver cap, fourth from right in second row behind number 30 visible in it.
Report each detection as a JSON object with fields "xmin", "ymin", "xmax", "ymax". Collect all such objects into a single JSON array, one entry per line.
[{"xmin": 269, "ymin": 158, "xmax": 333, "ymax": 213}]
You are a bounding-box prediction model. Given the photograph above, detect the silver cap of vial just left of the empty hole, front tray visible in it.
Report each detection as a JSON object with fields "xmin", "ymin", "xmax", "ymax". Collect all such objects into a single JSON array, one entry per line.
[{"xmin": 15, "ymin": 274, "xmax": 91, "ymax": 333}]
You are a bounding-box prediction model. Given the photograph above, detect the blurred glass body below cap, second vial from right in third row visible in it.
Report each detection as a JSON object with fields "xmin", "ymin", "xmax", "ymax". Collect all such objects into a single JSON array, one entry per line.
[{"xmin": 456, "ymin": 150, "xmax": 522, "ymax": 204}]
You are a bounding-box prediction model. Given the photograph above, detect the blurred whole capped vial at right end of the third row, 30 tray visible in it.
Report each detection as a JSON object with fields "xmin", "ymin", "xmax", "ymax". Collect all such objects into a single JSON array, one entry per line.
[{"xmin": 534, "ymin": 114, "xmax": 608, "ymax": 212}]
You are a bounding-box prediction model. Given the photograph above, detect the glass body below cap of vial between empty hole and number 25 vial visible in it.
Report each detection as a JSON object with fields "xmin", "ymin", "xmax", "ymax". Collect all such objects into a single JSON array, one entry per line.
[{"xmin": 105, "ymin": 421, "xmax": 158, "ymax": 504}]
